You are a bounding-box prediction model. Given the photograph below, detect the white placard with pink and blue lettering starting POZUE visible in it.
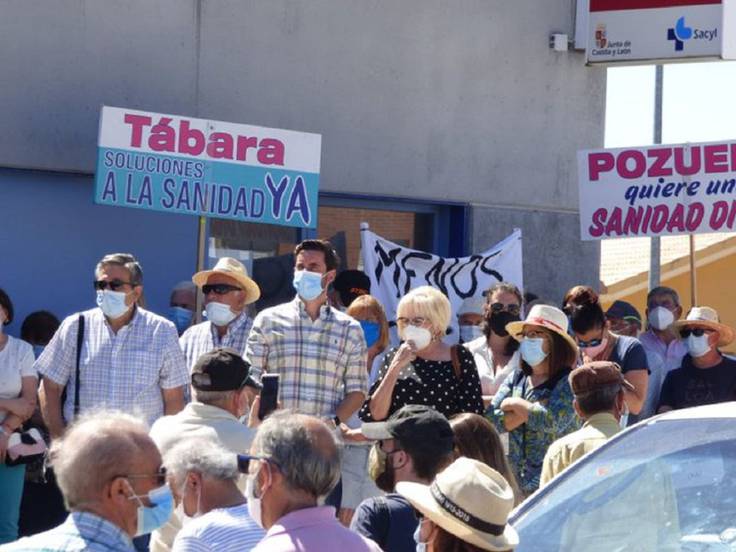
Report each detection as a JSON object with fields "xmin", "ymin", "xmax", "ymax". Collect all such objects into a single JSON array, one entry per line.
[{"xmin": 578, "ymin": 142, "xmax": 736, "ymax": 240}]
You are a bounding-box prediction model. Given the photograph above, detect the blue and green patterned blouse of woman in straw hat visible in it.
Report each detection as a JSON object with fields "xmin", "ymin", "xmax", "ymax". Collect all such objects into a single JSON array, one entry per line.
[{"xmin": 486, "ymin": 369, "xmax": 582, "ymax": 495}]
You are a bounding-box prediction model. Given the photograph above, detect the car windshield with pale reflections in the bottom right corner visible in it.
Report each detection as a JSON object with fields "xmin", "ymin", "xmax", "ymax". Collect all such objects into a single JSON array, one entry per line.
[{"xmin": 511, "ymin": 418, "xmax": 736, "ymax": 552}]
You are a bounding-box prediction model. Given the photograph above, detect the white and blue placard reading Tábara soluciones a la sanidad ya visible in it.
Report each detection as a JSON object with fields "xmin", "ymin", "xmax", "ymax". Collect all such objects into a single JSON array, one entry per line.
[{"xmin": 95, "ymin": 107, "xmax": 322, "ymax": 228}]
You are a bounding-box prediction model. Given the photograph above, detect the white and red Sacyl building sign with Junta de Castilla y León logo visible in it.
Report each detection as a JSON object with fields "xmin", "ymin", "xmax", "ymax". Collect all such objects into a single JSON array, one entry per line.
[{"xmin": 586, "ymin": 0, "xmax": 736, "ymax": 64}]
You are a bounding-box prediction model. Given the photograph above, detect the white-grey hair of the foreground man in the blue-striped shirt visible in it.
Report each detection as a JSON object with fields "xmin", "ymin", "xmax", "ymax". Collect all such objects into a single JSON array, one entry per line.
[{"xmin": 164, "ymin": 437, "xmax": 240, "ymax": 486}]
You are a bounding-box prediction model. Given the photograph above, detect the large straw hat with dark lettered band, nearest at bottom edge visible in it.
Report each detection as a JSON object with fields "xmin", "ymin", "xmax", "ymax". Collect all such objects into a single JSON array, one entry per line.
[{"xmin": 396, "ymin": 457, "xmax": 519, "ymax": 551}]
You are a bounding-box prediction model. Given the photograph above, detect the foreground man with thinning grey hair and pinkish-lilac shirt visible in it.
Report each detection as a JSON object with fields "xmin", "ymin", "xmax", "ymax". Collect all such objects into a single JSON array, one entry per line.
[{"xmin": 245, "ymin": 410, "xmax": 381, "ymax": 552}]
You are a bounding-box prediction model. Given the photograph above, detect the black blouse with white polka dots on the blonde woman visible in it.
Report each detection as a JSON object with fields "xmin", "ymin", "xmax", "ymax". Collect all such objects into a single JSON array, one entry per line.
[{"xmin": 358, "ymin": 347, "xmax": 483, "ymax": 422}]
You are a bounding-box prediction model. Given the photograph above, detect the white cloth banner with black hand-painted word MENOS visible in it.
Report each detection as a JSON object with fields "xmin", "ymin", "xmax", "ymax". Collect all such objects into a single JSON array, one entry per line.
[{"xmin": 360, "ymin": 228, "xmax": 524, "ymax": 345}]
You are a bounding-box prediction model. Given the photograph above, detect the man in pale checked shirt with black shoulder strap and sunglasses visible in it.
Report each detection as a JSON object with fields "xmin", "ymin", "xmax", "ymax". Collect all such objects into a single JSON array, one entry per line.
[{"xmin": 34, "ymin": 253, "xmax": 189, "ymax": 438}]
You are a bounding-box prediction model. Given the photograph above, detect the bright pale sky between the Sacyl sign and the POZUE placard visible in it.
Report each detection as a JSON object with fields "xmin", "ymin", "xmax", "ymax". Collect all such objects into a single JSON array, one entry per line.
[{"xmin": 605, "ymin": 61, "xmax": 736, "ymax": 148}]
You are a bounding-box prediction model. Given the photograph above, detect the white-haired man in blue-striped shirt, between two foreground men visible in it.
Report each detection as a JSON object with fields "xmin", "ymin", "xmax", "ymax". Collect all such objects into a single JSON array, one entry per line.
[{"xmin": 164, "ymin": 438, "xmax": 265, "ymax": 552}]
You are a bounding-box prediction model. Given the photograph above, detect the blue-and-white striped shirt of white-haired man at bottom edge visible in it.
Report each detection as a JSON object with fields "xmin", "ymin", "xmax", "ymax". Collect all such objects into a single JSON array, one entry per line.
[{"xmin": 171, "ymin": 504, "xmax": 266, "ymax": 552}]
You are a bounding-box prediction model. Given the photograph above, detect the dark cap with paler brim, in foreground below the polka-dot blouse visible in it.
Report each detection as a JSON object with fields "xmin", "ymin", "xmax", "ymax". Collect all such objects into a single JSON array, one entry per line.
[{"xmin": 361, "ymin": 404, "xmax": 454, "ymax": 455}]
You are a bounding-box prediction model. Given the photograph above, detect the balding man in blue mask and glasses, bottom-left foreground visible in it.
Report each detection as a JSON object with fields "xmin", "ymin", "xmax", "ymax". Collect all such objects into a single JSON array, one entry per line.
[{"xmin": 3, "ymin": 411, "xmax": 174, "ymax": 552}]
